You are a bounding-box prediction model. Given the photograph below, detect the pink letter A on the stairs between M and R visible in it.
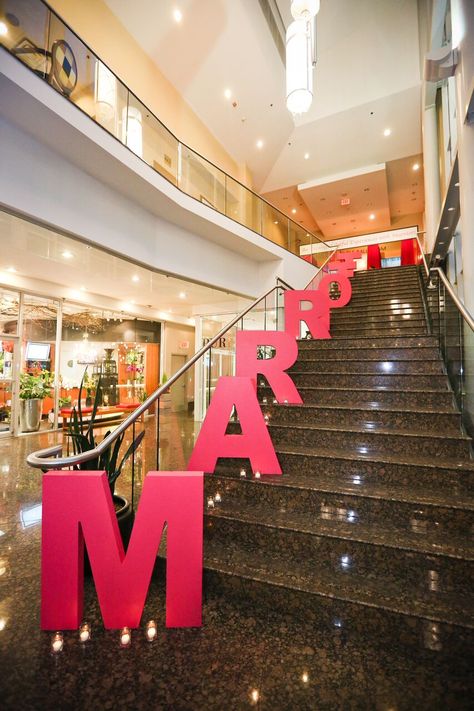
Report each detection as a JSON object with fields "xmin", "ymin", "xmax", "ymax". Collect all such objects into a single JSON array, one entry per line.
[{"xmin": 188, "ymin": 377, "xmax": 281, "ymax": 474}]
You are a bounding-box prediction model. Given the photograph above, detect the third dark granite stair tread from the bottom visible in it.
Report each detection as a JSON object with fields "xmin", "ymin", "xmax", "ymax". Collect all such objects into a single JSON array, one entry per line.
[{"xmin": 210, "ymin": 468, "xmax": 474, "ymax": 511}]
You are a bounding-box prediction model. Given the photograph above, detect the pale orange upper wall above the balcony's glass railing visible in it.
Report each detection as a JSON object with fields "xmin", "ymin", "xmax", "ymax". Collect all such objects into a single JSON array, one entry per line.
[{"xmin": 49, "ymin": 0, "xmax": 251, "ymax": 187}]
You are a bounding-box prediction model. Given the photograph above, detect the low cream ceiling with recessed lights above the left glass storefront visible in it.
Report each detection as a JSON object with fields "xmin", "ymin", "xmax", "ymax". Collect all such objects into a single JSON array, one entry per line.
[{"xmin": 0, "ymin": 211, "xmax": 249, "ymax": 321}]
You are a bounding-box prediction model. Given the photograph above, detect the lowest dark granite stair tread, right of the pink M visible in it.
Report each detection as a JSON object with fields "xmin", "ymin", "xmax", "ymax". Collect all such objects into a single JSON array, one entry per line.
[{"xmin": 204, "ymin": 545, "xmax": 474, "ymax": 627}]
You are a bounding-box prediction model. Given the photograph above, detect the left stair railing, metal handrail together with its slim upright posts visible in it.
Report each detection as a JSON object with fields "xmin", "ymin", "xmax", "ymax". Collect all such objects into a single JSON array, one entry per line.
[{"xmin": 27, "ymin": 279, "xmax": 291, "ymax": 478}]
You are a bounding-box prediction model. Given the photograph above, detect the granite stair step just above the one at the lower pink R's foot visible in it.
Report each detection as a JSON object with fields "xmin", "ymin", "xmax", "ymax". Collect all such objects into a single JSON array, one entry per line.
[{"xmin": 291, "ymin": 369, "xmax": 448, "ymax": 392}]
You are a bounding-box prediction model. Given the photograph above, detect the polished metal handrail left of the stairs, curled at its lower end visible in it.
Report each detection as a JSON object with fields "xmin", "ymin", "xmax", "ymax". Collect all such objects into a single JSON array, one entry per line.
[{"xmin": 26, "ymin": 285, "xmax": 291, "ymax": 469}]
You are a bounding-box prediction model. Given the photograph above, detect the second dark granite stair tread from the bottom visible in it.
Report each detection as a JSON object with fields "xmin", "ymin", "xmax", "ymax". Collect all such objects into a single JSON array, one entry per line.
[{"xmin": 206, "ymin": 500, "xmax": 474, "ymax": 561}]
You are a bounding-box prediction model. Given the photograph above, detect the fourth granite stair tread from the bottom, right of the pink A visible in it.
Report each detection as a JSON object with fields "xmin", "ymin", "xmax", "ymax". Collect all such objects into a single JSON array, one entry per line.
[{"xmin": 275, "ymin": 444, "xmax": 474, "ymax": 472}]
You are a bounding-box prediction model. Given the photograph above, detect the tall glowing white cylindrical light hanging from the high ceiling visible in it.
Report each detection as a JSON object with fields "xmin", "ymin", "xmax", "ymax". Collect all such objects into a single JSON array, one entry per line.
[{"xmin": 286, "ymin": 0, "xmax": 319, "ymax": 114}]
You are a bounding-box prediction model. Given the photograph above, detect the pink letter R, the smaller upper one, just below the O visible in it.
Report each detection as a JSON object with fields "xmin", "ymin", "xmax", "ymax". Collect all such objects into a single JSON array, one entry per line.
[{"xmin": 285, "ymin": 292, "xmax": 332, "ymax": 338}]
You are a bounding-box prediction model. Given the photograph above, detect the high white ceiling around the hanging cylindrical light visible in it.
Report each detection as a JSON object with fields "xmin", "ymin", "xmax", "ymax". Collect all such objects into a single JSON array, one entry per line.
[{"xmin": 106, "ymin": 0, "xmax": 421, "ymax": 210}]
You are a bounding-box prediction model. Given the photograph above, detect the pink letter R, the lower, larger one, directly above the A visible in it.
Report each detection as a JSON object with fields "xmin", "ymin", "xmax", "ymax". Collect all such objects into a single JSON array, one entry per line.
[{"xmin": 235, "ymin": 331, "xmax": 303, "ymax": 405}]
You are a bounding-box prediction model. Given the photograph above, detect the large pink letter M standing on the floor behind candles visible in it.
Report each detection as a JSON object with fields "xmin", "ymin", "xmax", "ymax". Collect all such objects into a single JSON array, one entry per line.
[{"xmin": 41, "ymin": 471, "xmax": 203, "ymax": 630}]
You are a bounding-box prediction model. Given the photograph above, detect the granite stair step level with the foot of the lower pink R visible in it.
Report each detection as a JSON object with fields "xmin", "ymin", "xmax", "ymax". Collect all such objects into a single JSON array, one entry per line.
[{"xmin": 258, "ymin": 380, "xmax": 455, "ymax": 412}]
